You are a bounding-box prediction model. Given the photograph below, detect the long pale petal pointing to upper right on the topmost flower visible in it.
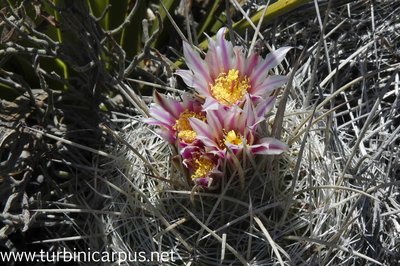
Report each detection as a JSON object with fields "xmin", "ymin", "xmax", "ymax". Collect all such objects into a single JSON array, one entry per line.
[{"xmin": 250, "ymin": 47, "xmax": 292, "ymax": 84}]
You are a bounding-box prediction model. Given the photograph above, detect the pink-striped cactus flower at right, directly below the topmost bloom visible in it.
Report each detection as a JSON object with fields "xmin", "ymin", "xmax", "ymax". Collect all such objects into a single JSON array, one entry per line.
[{"xmin": 189, "ymin": 96, "xmax": 288, "ymax": 158}]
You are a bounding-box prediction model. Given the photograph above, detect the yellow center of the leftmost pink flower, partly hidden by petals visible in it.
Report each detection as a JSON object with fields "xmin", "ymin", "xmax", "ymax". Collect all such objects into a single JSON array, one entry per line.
[{"xmin": 172, "ymin": 109, "xmax": 206, "ymax": 143}]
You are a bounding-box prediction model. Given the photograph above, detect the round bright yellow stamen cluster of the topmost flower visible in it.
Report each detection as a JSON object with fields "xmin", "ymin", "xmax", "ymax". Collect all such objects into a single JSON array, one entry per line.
[{"xmin": 210, "ymin": 69, "xmax": 250, "ymax": 106}]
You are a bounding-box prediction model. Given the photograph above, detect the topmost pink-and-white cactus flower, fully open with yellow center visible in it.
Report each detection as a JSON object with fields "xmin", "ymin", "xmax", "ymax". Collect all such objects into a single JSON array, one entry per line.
[{"xmin": 176, "ymin": 28, "xmax": 291, "ymax": 109}]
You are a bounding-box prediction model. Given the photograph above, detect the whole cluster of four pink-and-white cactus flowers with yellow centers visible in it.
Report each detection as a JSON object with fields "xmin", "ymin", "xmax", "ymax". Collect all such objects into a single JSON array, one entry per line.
[{"xmin": 144, "ymin": 28, "xmax": 290, "ymax": 188}]
